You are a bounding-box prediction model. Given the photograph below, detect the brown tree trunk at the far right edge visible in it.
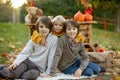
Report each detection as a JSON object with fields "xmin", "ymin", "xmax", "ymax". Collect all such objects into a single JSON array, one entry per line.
[{"xmin": 115, "ymin": 8, "xmax": 120, "ymax": 33}]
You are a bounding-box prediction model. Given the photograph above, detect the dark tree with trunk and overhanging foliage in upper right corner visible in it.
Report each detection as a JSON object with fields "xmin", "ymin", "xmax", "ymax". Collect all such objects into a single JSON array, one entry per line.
[{"xmin": 94, "ymin": 0, "xmax": 120, "ymax": 33}]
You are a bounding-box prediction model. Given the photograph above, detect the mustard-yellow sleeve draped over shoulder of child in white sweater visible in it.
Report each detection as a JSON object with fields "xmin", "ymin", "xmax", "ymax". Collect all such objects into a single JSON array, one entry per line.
[{"xmin": 31, "ymin": 31, "xmax": 43, "ymax": 44}]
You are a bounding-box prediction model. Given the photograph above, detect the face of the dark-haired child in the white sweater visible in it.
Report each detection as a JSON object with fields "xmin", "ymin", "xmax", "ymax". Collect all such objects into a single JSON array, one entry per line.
[{"xmin": 38, "ymin": 22, "xmax": 50, "ymax": 37}]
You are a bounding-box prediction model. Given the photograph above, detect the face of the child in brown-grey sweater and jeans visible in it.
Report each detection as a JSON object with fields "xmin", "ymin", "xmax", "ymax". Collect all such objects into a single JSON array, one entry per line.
[{"xmin": 66, "ymin": 24, "xmax": 78, "ymax": 40}]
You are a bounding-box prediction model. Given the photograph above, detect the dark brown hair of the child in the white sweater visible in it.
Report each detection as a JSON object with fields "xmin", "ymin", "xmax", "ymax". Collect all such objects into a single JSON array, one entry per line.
[{"xmin": 36, "ymin": 16, "xmax": 53, "ymax": 32}]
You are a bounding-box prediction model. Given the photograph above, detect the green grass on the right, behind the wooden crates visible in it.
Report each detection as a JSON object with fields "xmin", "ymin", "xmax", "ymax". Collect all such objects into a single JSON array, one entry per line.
[{"xmin": 92, "ymin": 26, "xmax": 120, "ymax": 51}]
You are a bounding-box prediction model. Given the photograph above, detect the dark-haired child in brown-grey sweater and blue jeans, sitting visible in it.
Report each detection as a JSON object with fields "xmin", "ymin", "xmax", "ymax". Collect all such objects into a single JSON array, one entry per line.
[{"xmin": 50, "ymin": 20, "xmax": 100, "ymax": 77}]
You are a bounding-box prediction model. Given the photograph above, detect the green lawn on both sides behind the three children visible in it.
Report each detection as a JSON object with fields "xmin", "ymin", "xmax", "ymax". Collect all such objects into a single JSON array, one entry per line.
[{"xmin": 0, "ymin": 23, "xmax": 120, "ymax": 54}]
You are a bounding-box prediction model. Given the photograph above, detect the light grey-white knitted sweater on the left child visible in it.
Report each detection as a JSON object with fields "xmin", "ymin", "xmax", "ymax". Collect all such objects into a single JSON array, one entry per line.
[{"xmin": 13, "ymin": 33, "xmax": 58, "ymax": 73}]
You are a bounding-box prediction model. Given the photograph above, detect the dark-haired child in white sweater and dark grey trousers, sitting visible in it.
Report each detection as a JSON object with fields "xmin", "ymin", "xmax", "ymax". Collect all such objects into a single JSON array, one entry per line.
[{"xmin": 0, "ymin": 16, "xmax": 58, "ymax": 80}]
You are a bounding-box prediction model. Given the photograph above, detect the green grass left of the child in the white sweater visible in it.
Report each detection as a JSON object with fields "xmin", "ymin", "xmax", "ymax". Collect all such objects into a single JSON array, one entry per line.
[{"xmin": 0, "ymin": 23, "xmax": 29, "ymax": 53}]
